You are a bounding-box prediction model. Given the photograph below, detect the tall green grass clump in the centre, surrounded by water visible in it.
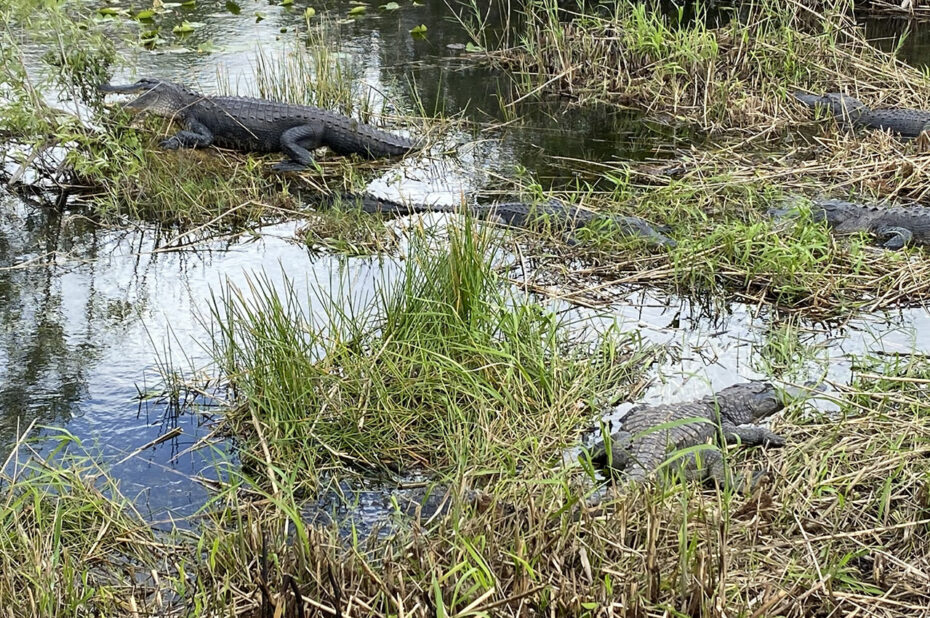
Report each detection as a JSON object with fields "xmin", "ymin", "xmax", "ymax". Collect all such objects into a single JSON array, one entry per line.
[{"xmin": 213, "ymin": 220, "xmax": 645, "ymax": 480}]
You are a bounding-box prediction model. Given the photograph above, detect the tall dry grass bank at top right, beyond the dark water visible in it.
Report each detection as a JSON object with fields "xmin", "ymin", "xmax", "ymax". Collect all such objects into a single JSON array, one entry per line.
[{"xmin": 482, "ymin": 0, "xmax": 930, "ymax": 133}]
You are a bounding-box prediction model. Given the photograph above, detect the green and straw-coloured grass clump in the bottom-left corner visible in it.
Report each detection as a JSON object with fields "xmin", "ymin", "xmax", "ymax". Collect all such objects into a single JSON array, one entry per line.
[{"xmin": 0, "ymin": 433, "xmax": 165, "ymax": 618}]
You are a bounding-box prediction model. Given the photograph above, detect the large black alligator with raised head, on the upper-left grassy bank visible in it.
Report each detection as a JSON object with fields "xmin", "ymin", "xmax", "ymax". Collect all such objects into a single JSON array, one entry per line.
[{"xmin": 99, "ymin": 78, "xmax": 417, "ymax": 172}]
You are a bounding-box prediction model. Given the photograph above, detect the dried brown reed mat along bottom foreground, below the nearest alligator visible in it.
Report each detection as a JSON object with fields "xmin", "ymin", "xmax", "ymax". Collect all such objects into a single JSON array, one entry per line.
[{"xmin": 181, "ymin": 359, "xmax": 930, "ymax": 617}]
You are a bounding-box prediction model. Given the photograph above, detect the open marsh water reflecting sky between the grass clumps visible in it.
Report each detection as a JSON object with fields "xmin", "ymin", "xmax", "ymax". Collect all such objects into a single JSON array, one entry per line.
[{"xmin": 0, "ymin": 0, "xmax": 930, "ymax": 521}]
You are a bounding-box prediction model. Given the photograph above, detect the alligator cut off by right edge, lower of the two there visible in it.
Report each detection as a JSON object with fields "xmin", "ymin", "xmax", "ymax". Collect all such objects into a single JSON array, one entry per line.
[{"xmin": 769, "ymin": 199, "xmax": 930, "ymax": 249}]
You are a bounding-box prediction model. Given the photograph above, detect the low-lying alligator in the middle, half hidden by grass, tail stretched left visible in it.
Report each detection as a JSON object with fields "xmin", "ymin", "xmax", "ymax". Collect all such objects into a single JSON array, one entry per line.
[{"xmin": 338, "ymin": 194, "xmax": 676, "ymax": 248}]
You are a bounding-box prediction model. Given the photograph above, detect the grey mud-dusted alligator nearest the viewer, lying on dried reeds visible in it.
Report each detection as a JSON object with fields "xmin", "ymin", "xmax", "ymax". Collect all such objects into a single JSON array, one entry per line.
[{"xmin": 591, "ymin": 381, "xmax": 788, "ymax": 488}]
